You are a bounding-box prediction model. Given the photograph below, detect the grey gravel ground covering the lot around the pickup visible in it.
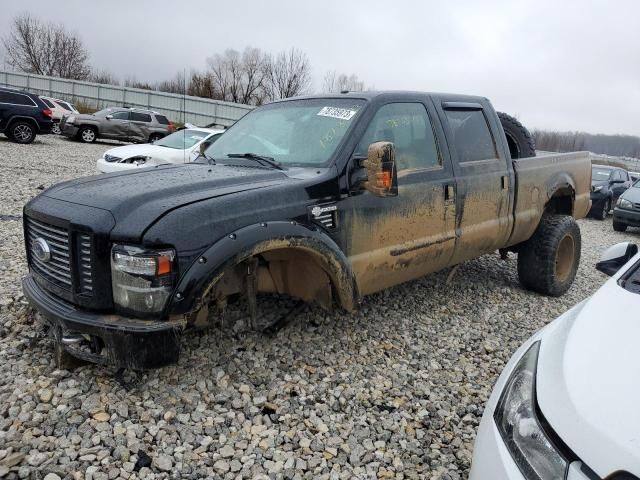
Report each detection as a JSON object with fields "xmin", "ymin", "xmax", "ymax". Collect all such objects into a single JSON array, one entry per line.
[{"xmin": 0, "ymin": 136, "xmax": 637, "ymax": 480}]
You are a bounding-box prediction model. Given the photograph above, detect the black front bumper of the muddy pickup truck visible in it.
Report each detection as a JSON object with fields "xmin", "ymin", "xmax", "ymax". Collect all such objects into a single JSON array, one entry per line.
[{"xmin": 22, "ymin": 274, "xmax": 186, "ymax": 370}]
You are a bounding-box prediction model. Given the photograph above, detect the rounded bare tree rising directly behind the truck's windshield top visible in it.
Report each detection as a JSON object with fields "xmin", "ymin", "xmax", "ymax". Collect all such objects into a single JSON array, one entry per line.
[{"xmin": 265, "ymin": 48, "xmax": 311, "ymax": 100}]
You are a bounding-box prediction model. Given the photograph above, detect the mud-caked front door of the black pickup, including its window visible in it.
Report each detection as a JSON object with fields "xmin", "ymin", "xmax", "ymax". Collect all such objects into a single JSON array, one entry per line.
[{"xmin": 340, "ymin": 97, "xmax": 456, "ymax": 295}]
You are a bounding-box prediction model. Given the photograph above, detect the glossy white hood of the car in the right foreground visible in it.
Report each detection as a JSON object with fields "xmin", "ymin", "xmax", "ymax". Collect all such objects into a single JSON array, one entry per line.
[{"xmin": 536, "ymin": 272, "xmax": 640, "ymax": 478}]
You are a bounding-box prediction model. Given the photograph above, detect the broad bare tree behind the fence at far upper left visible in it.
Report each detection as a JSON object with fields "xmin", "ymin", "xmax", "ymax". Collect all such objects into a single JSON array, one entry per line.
[{"xmin": 2, "ymin": 13, "xmax": 91, "ymax": 80}]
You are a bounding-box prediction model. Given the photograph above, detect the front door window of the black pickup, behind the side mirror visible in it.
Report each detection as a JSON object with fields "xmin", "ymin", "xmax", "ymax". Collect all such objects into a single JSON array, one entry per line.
[{"xmin": 358, "ymin": 103, "xmax": 442, "ymax": 171}]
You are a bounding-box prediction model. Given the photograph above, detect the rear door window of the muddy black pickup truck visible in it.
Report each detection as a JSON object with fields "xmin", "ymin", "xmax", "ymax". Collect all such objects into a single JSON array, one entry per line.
[{"xmin": 444, "ymin": 110, "xmax": 498, "ymax": 163}]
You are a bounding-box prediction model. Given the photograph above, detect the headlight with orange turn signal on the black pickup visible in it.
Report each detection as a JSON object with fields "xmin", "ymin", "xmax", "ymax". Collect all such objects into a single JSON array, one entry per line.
[{"xmin": 111, "ymin": 245, "xmax": 176, "ymax": 316}]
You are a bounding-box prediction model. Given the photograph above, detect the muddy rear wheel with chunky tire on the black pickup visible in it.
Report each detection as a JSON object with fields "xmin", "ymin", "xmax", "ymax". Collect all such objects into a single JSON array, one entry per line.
[{"xmin": 518, "ymin": 215, "xmax": 582, "ymax": 297}]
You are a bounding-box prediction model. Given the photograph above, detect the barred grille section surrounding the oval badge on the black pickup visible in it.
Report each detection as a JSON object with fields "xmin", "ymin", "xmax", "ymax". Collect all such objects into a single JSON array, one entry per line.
[{"xmin": 27, "ymin": 218, "xmax": 73, "ymax": 290}]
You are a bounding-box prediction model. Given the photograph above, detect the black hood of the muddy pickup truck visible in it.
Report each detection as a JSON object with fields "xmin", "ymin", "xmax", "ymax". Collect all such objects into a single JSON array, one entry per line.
[{"xmin": 42, "ymin": 164, "xmax": 288, "ymax": 240}]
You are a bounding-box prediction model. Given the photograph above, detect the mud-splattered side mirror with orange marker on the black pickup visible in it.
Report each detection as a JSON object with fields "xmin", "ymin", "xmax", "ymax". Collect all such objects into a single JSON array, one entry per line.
[{"xmin": 362, "ymin": 142, "xmax": 398, "ymax": 197}]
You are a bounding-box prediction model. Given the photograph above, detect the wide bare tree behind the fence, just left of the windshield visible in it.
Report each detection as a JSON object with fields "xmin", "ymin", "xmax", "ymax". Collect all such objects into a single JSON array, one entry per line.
[{"xmin": 207, "ymin": 47, "xmax": 267, "ymax": 105}]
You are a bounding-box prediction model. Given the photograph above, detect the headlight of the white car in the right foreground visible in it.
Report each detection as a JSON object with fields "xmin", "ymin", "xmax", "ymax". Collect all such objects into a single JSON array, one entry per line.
[{"xmin": 494, "ymin": 342, "xmax": 569, "ymax": 480}]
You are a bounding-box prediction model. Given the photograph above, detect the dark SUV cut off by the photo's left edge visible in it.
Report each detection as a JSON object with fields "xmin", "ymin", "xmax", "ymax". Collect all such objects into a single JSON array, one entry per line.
[{"xmin": 0, "ymin": 87, "xmax": 53, "ymax": 143}]
